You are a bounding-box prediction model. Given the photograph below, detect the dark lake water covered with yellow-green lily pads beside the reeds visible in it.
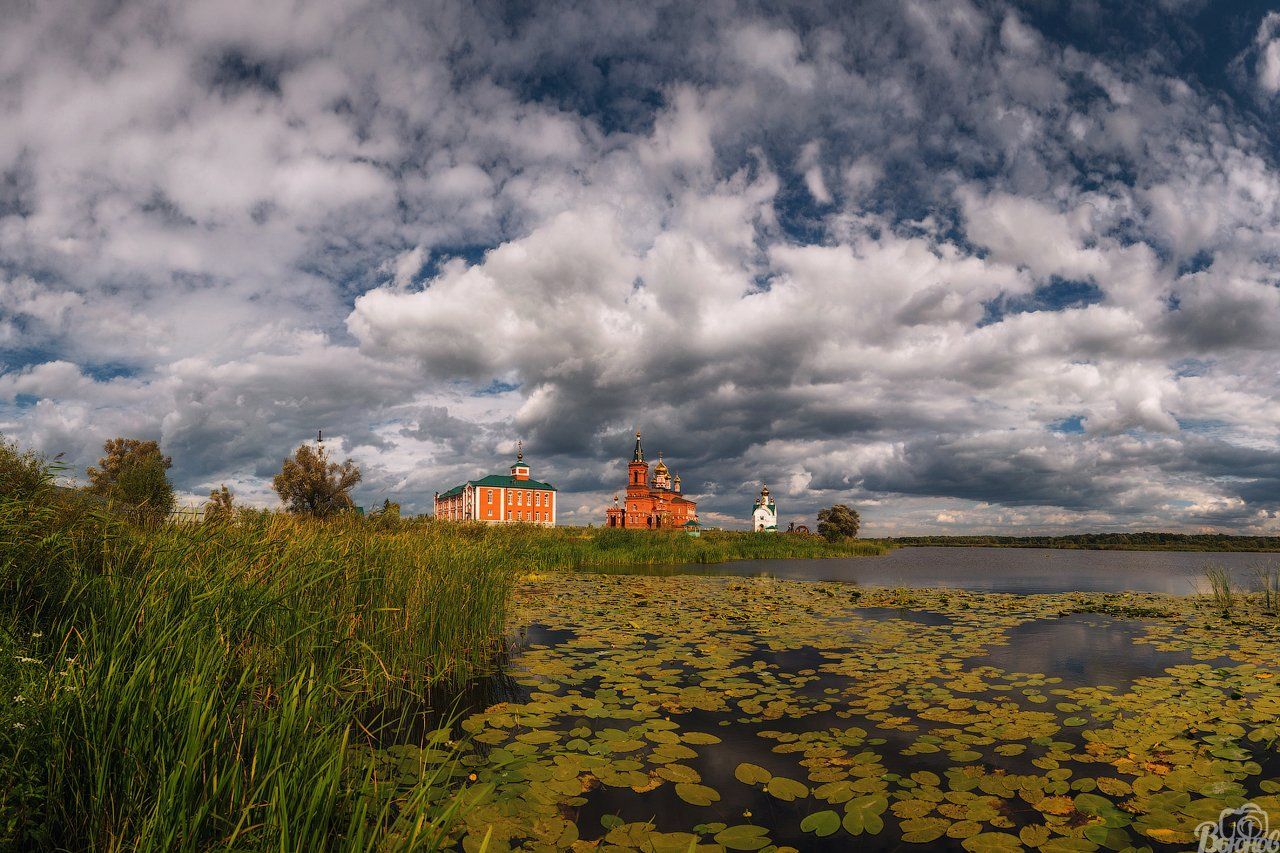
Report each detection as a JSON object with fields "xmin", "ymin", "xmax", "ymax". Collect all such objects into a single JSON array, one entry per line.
[{"xmin": 432, "ymin": 568, "xmax": 1280, "ymax": 853}]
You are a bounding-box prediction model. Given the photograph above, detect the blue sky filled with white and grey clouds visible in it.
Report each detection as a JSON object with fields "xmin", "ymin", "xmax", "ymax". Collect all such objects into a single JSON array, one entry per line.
[{"xmin": 0, "ymin": 0, "xmax": 1280, "ymax": 535}]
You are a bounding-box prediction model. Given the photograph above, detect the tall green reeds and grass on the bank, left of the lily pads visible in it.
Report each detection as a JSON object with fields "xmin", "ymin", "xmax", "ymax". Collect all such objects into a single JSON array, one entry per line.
[{"xmin": 0, "ymin": 448, "xmax": 877, "ymax": 850}]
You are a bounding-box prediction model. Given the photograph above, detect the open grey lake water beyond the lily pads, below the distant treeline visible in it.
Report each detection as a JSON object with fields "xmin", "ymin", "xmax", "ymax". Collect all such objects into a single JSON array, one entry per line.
[{"xmin": 586, "ymin": 547, "xmax": 1280, "ymax": 596}]
